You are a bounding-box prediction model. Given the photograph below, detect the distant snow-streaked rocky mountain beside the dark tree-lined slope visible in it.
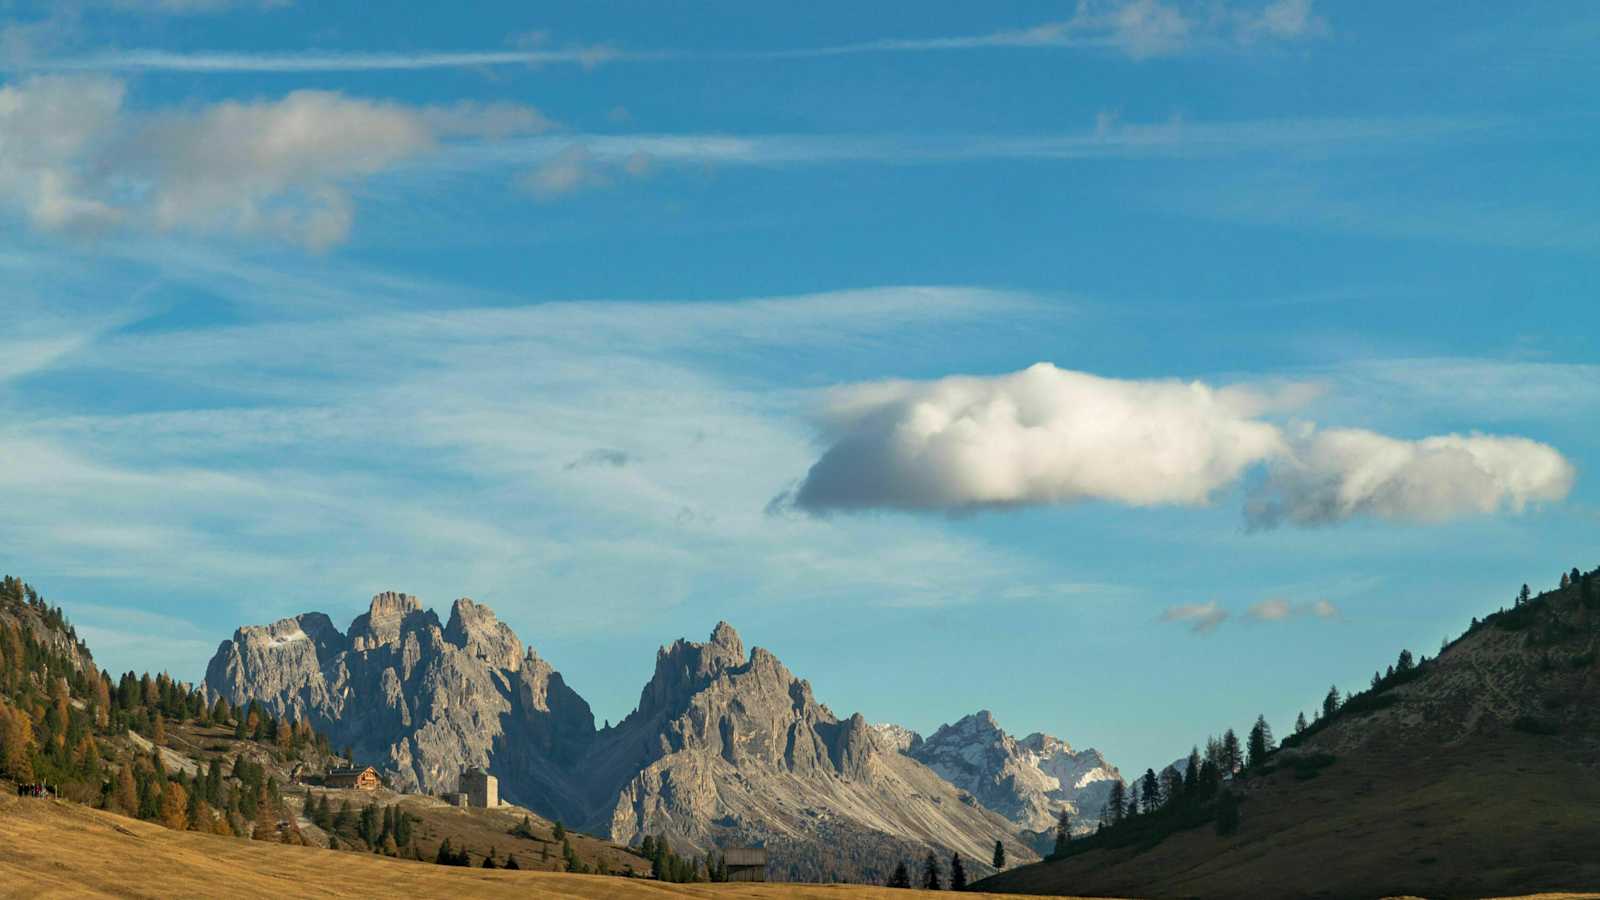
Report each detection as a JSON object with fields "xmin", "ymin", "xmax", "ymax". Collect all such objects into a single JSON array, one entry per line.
[{"xmin": 878, "ymin": 709, "xmax": 1122, "ymax": 833}]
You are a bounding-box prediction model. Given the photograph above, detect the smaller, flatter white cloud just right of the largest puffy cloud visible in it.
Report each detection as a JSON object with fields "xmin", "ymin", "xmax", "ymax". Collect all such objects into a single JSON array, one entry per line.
[{"xmin": 1246, "ymin": 429, "xmax": 1576, "ymax": 527}]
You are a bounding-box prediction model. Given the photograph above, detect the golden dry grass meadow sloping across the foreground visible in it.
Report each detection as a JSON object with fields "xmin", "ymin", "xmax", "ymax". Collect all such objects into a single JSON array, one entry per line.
[{"xmin": 0, "ymin": 796, "xmax": 1088, "ymax": 900}]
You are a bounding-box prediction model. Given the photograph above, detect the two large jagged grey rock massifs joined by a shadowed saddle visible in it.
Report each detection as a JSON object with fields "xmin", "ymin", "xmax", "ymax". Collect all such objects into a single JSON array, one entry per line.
[{"xmin": 206, "ymin": 594, "xmax": 1049, "ymax": 881}]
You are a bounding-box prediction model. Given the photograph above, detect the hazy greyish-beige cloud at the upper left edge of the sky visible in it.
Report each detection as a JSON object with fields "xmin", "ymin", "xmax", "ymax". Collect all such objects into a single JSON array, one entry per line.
[{"xmin": 0, "ymin": 77, "xmax": 549, "ymax": 248}]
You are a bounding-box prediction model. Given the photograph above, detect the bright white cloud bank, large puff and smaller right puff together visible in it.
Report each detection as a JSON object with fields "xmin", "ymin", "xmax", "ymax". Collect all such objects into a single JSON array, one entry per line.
[{"xmin": 790, "ymin": 364, "xmax": 1574, "ymax": 525}]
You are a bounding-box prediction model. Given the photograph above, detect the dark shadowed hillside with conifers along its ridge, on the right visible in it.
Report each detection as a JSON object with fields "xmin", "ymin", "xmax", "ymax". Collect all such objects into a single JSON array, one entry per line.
[{"xmin": 979, "ymin": 573, "xmax": 1600, "ymax": 897}]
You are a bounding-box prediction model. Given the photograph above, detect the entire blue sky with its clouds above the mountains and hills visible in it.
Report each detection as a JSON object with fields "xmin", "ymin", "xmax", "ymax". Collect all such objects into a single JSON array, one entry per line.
[{"xmin": 0, "ymin": 0, "xmax": 1600, "ymax": 770}]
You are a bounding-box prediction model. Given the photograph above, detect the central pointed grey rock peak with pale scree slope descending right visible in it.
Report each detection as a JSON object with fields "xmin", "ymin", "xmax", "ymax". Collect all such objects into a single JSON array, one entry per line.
[{"xmin": 587, "ymin": 623, "xmax": 1034, "ymax": 879}]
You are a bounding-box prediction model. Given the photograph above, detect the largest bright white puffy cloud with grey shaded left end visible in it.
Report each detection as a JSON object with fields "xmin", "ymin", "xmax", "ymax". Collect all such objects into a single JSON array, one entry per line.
[{"xmin": 795, "ymin": 364, "xmax": 1283, "ymax": 511}]
